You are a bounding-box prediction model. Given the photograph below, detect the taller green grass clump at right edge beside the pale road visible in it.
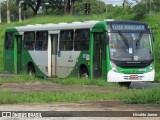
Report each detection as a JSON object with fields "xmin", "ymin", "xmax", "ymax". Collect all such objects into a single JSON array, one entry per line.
[{"xmin": 126, "ymin": 88, "xmax": 160, "ymax": 104}]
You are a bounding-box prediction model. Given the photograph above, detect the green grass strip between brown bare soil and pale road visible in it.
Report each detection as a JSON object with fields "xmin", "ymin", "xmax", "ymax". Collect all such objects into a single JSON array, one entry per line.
[{"xmin": 0, "ymin": 91, "xmax": 127, "ymax": 104}]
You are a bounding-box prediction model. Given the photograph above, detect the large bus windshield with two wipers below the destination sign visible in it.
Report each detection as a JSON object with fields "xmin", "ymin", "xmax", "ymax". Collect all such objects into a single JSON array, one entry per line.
[{"xmin": 109, "ymin": 31, "xmax": 153, "ymax": 61}]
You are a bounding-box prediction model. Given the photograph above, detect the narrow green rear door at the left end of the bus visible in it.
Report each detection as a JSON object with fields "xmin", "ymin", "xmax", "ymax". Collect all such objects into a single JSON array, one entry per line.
[{"xmin": 15, "ymin": 35, "xmax": 22, "ymax": 73}]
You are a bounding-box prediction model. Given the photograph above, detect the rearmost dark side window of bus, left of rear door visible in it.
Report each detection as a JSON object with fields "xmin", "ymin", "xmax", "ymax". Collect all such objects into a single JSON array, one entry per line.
[{"xmin": 5, "ymin": 32, "xmax": 14, "ymax": 50}]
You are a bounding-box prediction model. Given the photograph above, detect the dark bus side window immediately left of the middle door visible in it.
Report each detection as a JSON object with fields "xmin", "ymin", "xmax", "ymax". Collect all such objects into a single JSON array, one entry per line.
[{"xmin": 35, "ymin": 31, "xmax": 48, "ymax": 50}]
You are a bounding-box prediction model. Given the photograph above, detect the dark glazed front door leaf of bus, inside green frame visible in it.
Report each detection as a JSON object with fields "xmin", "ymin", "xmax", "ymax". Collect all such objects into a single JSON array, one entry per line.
[{"xmin": 93, "ymin": 33, "xmax": 103, "ymax": 78}]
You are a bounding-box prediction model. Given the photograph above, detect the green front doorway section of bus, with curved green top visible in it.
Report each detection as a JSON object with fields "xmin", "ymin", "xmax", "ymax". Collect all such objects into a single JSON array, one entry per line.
[{"xmin": 90, "ymin": 21, "xmax": 109, "ymax": 80}]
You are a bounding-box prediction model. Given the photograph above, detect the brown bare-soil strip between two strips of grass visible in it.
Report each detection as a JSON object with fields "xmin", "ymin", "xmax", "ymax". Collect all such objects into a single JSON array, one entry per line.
[{"xmin": 0, "ymin": 82, "xmax": 125, "ymax": 93}]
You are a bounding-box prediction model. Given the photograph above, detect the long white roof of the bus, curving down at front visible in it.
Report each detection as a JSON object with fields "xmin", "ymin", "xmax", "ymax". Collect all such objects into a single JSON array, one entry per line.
[{"xmin": 6, "ymin": 19, "xmax": 148, "ymax": 32}]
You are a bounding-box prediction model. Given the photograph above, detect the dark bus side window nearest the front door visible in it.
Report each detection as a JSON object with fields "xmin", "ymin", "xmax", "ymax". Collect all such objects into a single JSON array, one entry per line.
[{"xmin": 74, "ymin": 29, "xmax": 90, "ymax": 51}]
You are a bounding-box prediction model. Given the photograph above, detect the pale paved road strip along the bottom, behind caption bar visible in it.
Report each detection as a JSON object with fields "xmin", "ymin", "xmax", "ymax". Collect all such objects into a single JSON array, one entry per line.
[{"xmin": 0, "ymin": 101, "xmax": 160, "ymax": 120}]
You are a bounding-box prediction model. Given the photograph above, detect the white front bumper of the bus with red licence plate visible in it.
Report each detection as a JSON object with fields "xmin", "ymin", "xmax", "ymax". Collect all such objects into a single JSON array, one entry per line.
[{"xmin": 107, "ymin": 70, "xmax": 155, "ymax": 82}]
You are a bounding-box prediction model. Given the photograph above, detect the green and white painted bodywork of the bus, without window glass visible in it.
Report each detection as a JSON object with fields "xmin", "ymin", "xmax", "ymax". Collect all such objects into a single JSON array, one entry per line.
[{"xmin": 4, "ymin": 21, "xmax": 155, "ymax": 82}]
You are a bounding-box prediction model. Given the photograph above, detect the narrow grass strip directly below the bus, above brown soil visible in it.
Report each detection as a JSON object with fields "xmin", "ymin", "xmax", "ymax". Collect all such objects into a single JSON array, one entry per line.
[{"xmin": 0, "ymin": 74, "xmax": 123, "ymax": 89}]
